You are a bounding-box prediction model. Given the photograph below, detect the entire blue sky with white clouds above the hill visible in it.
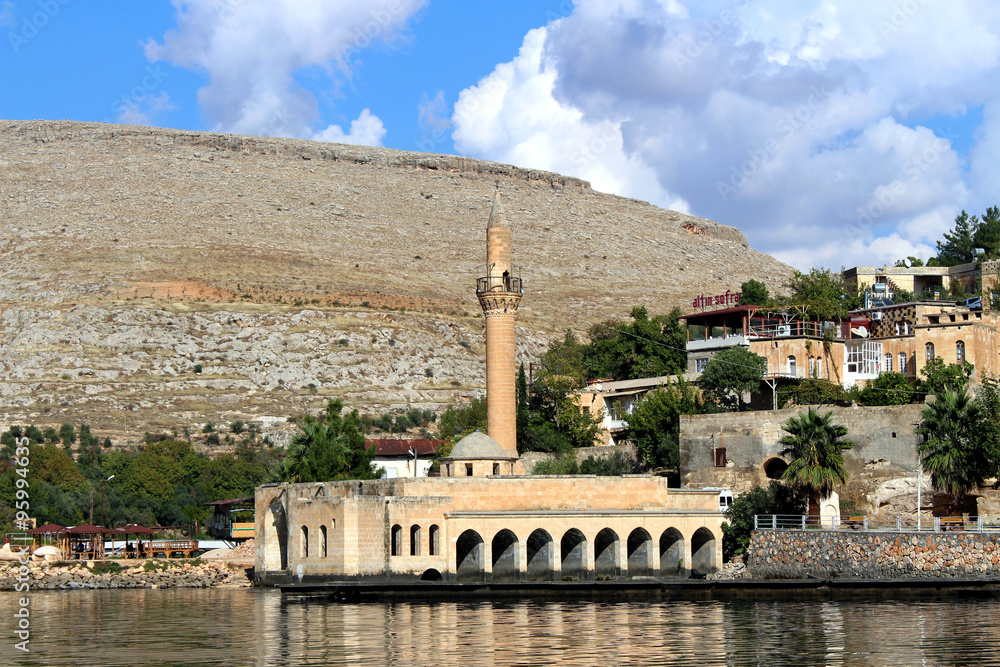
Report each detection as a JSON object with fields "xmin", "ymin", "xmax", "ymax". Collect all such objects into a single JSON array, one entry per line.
[{"xmin": 0, "ymin": 0, "xmax": 1000, "ymax": 270}]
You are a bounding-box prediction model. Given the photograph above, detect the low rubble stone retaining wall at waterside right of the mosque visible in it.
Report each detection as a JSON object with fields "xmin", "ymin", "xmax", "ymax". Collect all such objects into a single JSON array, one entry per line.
[{"xmin": 747, "ymin": 530, "xmax": 1000, "ymax": 579}]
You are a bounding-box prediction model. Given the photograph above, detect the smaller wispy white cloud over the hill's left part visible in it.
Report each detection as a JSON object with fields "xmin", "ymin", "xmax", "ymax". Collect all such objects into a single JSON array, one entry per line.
[{"xmin": 146, "ymin": 0, "xmax": 427, "ymax": 142}]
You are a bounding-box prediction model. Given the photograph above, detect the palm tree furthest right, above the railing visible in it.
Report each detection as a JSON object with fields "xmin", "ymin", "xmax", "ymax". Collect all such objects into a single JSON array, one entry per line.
[{"xmin": 917, "ymin": 387, "xmax": 991, "ymax": 510}]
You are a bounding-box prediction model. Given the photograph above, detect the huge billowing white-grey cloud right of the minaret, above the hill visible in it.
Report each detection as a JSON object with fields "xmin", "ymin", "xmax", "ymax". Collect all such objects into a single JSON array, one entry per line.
[{"xmin": 452, "ymin": 0, "xmax": 1000, "ymax": 268}]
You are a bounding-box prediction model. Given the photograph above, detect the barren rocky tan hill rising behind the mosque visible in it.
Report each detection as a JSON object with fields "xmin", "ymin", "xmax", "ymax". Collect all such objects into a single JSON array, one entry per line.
[{"xmin": 0, "ymin": 121, "xmax": 791, "ymax": 439}]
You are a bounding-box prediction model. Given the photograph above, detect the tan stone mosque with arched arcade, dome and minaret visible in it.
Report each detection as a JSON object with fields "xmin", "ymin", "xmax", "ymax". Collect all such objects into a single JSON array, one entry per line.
[{"xmin": 255, "ymin": 193, "xmax": 723, "ymax": 585}]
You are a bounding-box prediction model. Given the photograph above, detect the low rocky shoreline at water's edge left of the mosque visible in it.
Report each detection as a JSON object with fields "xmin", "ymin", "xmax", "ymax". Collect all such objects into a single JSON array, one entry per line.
[{"xmin": 0, "ymin": 559, "xmax": 253, "ymax": 591}]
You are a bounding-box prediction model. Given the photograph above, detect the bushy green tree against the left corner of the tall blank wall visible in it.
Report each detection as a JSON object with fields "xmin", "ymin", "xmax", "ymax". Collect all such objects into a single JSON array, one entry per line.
[{"xmin": 628, "ymin": 381, "xmax": 705, "ymax": 469}]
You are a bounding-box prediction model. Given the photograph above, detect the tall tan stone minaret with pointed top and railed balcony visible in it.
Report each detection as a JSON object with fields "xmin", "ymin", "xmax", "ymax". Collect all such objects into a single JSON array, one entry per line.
[{"xmin": 476, "ymin": 188, "xmax": 524, "ymax": 458}]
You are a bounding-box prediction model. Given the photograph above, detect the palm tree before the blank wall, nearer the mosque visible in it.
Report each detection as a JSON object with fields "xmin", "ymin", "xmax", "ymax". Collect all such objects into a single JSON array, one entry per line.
[{"xmin": 778, "ymin": 408, "xmax": 854, "ymax": 516}]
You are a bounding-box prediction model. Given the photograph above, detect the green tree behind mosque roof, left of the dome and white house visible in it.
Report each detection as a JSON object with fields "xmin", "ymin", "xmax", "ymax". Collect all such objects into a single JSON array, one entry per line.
[{"xmin": 283, "ymin": 400, "xmax": 378, "ymax": 482}]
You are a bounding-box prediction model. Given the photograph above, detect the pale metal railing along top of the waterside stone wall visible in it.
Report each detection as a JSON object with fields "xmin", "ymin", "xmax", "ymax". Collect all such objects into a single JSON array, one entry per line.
[{"xmin": 753, "ymin": 514, "xmax": 1000, "ymax": 533}]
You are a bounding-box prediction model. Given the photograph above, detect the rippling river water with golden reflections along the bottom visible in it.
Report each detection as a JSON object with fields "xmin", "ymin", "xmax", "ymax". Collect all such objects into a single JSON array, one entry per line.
[{"xmin": 0, "ymin": 589, "xmax": 1000, "ymax": 667}]
